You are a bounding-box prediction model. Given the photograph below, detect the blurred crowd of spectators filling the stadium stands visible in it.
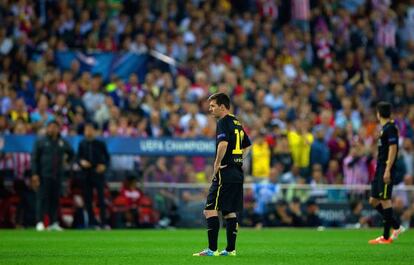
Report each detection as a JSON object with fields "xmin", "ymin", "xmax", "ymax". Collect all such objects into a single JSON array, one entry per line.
[{"xmin": 0, "ymin": 0, "xmax": 414, "ymax": 225}]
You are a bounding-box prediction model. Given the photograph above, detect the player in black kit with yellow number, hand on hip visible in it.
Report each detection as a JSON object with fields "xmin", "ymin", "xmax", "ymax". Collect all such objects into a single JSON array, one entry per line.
[{"xmin": 193, "ymin": 93, "xmax": 251, "ymax": 256}]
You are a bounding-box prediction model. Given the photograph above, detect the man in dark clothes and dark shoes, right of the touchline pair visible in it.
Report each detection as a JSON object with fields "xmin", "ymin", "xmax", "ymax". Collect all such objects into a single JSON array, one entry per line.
[{"xmin": 78, "ymin": 123, "xmax": 109, "ymax": 227}]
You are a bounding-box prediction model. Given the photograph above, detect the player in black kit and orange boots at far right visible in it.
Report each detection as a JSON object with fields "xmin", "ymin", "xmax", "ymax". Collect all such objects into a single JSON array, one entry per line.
[{"xmin": 368, "ymin": 102, "xmax": 404, "ymax": 244}]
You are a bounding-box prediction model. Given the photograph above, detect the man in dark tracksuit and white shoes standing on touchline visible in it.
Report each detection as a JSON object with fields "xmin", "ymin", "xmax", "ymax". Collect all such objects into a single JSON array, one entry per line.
[{"xmin": 31, "ymin": 121, "xmax": 74, "ymax": 231}]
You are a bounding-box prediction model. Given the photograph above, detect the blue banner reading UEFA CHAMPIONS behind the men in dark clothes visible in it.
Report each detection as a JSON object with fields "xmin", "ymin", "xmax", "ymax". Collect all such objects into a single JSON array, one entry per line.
[{"xmin": 0, "ymin": 135, "xmax": 216, "ymax": 156}]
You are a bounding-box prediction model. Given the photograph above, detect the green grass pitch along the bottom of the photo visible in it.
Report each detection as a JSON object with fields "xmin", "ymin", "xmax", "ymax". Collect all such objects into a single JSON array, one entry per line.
[{"xmin": 0, "ymin": 228, "xmax": 414, "ymax": 265}]
